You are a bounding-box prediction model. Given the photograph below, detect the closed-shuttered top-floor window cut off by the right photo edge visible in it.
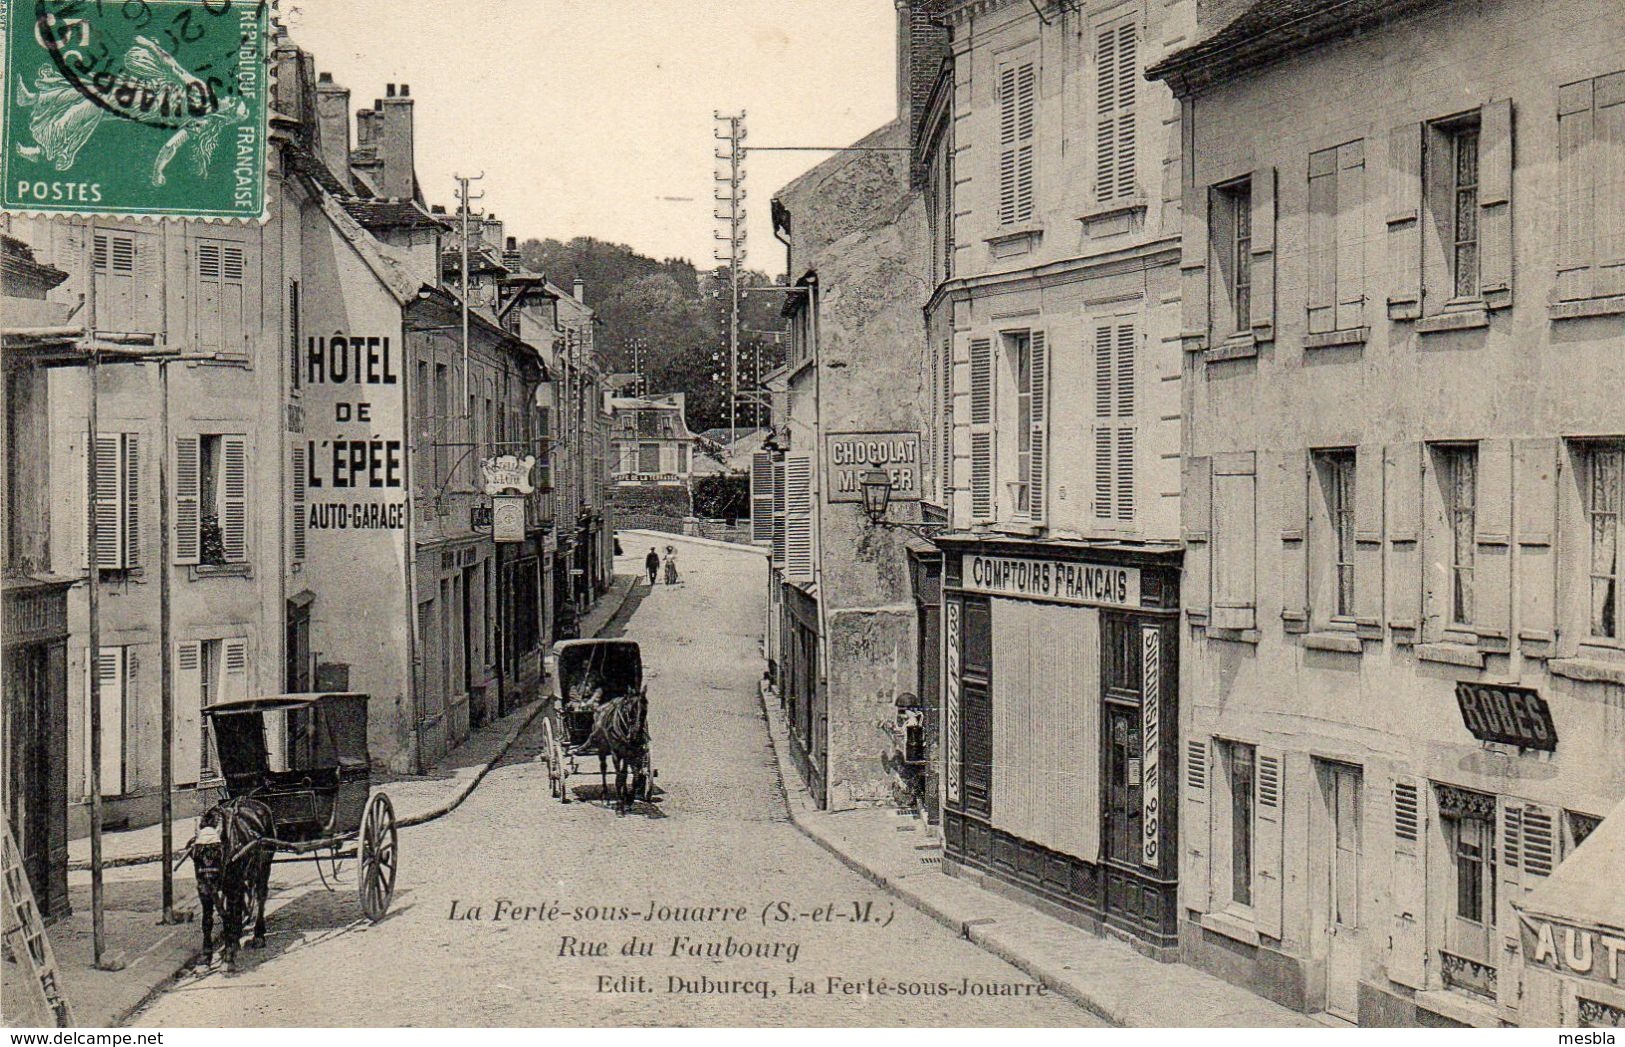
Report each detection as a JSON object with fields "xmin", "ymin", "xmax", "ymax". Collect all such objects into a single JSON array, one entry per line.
[{"xmin": 1557, "ymin": 70, "xmax": 1625, "ymax": 301}]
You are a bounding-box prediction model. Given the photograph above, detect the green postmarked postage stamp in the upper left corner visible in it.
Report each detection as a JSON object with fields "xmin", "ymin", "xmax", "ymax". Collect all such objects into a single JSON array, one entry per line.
[{"xmin": 0, "ymin": 0, "xmax": 270, "ymax": 221}]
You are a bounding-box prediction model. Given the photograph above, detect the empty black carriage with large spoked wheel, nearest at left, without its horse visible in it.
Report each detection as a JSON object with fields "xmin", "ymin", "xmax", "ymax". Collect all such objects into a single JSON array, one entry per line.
[{"xmin": 203, "ymin": 693, "xmax": 398, "ymax": 922}]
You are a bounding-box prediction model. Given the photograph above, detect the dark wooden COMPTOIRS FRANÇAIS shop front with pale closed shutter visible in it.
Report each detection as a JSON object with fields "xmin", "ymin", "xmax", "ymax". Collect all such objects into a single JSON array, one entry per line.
[{"xmin": 936, "ymin": 535, "xmax": 1180, "ymax": 959}]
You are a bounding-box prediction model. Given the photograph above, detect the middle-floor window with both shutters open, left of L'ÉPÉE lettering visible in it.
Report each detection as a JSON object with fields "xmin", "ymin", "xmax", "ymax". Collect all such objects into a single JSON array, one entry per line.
[{"xmin": 174, "ymin": 434, "xmax": 249, "ymax": 567}]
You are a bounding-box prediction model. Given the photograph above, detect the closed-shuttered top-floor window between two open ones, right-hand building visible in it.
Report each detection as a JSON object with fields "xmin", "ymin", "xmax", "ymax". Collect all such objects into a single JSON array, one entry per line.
[{"xmin": 1308, "ymin": 141, "xmax": 1365, "ymax": 335}]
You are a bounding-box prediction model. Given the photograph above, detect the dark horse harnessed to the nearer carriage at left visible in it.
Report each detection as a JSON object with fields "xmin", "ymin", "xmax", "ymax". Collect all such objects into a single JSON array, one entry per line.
[{"xmin": 190, "ymin": 797, "xmax": 276, "ymax": 971}]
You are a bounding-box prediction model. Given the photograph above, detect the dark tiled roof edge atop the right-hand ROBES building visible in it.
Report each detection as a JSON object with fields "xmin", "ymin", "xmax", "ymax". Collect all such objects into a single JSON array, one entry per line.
[{"xmin": 1146, "ymin": 0, "xmax": 1437, "ymax": 96}]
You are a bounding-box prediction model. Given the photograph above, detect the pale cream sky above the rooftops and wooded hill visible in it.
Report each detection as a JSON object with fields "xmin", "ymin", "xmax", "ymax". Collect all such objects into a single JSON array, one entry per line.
[{"xmin": 289, "ymin": 0, "xmax": 897, "ymax": 275}]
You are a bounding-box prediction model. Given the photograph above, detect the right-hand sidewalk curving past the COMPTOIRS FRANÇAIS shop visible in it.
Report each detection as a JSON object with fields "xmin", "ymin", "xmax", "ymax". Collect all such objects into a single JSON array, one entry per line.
[{"xmin": 762, "ymin": 679, "xmax": 1320, "ymax": 1027}]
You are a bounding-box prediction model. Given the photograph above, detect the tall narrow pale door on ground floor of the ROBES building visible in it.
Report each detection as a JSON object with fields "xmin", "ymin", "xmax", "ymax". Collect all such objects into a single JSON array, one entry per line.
[{"xmin": 1318, "ymin": 762, "xmax": 1360, "ymax": 1021}]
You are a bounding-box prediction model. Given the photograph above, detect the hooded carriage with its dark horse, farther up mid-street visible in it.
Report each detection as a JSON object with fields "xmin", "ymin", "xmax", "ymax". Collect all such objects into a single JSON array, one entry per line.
[{"xmin": 543, "ymin": 639, "xmax": 658, "ymax": 811}]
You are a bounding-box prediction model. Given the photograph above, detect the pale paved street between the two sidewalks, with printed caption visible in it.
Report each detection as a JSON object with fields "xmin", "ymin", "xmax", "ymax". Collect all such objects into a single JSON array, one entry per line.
[{"xmin": 137, "ymin": 543, "xmax": 1099, "ymax": 1026}]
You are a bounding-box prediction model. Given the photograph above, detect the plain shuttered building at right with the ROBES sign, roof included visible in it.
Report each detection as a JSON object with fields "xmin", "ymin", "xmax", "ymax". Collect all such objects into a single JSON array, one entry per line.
[{"xmin": 1152, "ymin": 2, "xmax": 1625, "ymax": 1026}]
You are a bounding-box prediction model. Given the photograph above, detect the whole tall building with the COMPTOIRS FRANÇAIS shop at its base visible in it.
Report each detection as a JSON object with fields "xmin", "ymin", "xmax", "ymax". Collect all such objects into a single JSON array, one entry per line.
[{"xmin": 915, "ymin": 0, "xmax": 1194, "ymax": 959}]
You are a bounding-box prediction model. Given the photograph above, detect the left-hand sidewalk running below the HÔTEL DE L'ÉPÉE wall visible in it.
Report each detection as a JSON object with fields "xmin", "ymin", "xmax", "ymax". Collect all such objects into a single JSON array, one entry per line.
[{"xmin": 34, "ymin": 574, "xmax": 635, "ymax": 1027}]
